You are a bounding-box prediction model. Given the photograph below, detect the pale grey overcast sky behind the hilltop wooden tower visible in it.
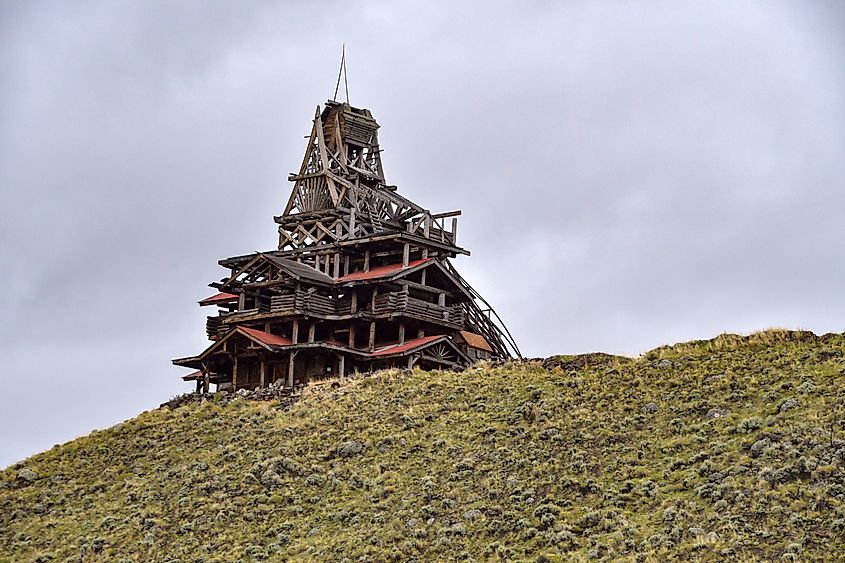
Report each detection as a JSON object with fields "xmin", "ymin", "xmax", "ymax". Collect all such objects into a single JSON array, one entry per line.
[{"xmin": 0, "ymin": 0, "xmax": 845, "ymax": 467}]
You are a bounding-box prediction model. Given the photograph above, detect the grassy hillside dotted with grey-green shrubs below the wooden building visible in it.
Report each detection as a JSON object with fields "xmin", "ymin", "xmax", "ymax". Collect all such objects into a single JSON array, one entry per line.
[{"xmin": 0, "ymin": 331, "xmax": 845, "ymax": 561}]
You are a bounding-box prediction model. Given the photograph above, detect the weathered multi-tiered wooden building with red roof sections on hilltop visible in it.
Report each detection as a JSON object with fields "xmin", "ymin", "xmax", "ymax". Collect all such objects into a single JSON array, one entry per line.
[{"xmin": 173, "ymin": 101, "xmax": 520, "ymax": 392}]
